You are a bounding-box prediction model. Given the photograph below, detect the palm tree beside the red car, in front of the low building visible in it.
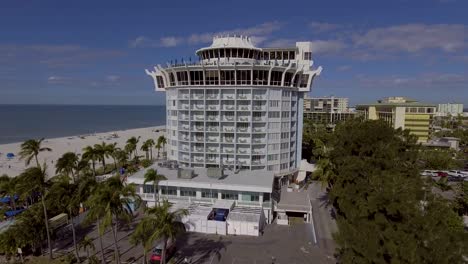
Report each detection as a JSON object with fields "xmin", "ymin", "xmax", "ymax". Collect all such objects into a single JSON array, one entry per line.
[{"xmin": 146, "ymin": 200, "xmax": 188, "ymax": 264}]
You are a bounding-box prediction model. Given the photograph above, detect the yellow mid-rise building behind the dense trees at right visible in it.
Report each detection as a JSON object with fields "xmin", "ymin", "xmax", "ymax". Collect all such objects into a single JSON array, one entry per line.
[{"xmin": 356, "ymin": 97, "xmax": 436, "ymax": 142}]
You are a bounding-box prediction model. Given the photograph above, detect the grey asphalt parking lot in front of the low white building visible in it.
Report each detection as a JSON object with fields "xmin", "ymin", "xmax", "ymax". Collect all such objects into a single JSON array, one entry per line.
[{"xmin": 170, "ymin": 224, "xmax": 335, "ymax": 264}]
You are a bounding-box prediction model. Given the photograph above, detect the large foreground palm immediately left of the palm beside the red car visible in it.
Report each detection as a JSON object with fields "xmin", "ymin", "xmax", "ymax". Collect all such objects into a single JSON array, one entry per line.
[{"xmin": 89, "ymin": 176, "xmax": 139, "ymax": 264}]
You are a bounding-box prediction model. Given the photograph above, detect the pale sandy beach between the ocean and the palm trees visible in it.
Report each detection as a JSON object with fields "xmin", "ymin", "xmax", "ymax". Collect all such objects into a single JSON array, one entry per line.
[{"xmin": 0, "ymin": 126, "xmax": 167, "ymax": 177}]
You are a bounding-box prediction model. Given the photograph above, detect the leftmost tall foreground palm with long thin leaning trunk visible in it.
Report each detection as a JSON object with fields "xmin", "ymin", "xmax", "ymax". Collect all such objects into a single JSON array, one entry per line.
[{"xmin": 18, "ymin": 164, "xmax": 53, "ymax": 260}]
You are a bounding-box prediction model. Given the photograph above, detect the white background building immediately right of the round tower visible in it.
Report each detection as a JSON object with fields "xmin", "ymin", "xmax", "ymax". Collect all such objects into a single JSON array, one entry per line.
[{"xmin": 304, "ymin": 96, "xmax": 356, "ymax": 125}]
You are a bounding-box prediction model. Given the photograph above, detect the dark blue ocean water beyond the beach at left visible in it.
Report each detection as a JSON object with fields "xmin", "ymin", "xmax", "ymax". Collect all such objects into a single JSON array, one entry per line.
[{"xmin": 0, "ymin": 105, "xmax": 166, "ymax": 144}]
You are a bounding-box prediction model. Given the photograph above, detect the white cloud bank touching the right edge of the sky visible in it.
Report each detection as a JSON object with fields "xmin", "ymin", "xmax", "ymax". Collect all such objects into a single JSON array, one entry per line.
[{"xmin": 353, "ymin": 24, "xmax": 468, "ymax": 53}]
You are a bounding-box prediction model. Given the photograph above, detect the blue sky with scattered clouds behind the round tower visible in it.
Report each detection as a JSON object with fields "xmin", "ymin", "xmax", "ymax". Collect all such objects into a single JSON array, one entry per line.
[{"xmin": 0, "ymin": 0, "xmax": 468, "ymax": 105}]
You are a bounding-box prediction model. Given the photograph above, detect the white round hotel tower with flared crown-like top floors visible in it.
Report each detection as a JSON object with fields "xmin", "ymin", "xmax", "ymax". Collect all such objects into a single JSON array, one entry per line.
[{"xmin": 146, "ymin": 36, "xmax": 322, "ymax": 173}]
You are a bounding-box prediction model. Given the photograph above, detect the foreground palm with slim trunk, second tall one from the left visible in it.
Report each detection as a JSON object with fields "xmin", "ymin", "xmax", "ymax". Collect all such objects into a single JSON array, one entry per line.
[{"xmin": 47, "ymin": 176, "xmax": 80, "ymax": 260}]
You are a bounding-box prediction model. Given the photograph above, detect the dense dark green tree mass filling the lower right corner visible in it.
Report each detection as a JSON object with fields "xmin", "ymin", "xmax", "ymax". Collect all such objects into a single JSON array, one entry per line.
[{"xmin": 320, "ymin": 120, "xmax": 468, "ymax": 263}]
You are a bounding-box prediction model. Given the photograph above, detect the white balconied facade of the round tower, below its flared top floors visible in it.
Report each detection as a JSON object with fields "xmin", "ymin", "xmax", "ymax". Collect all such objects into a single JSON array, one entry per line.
[{"xmin": 166, "ymin": 86, "xmax": 302, "ymax": 171}]
